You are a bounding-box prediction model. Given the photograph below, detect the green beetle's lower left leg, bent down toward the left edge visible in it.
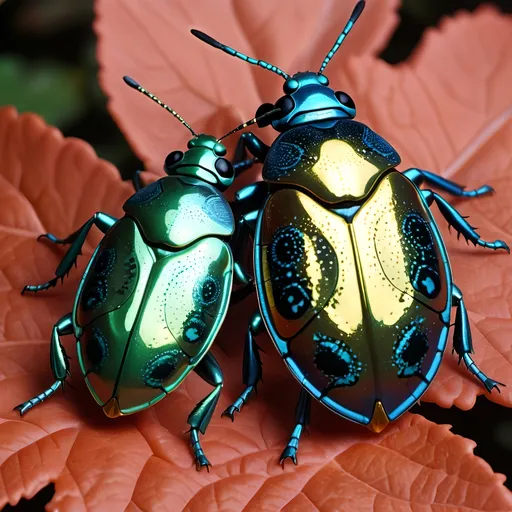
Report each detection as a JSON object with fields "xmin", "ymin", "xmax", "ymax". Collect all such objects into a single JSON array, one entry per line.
[{"xmin": 14, "ymin": 313, "xmax": 73, "ymax": 416}]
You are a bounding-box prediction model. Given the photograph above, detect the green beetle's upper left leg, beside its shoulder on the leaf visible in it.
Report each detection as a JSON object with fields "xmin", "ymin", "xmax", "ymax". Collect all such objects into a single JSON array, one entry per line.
[{"xmin": 21, "ymin": 212, "xmax": 118, "ymax": 295}]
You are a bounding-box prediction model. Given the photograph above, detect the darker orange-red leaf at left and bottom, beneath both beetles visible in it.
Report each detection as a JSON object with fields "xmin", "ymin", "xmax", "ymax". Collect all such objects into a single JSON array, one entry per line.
[{"xmin": 0, "ymin": 109, "xmax": 512, "ymax": 512}]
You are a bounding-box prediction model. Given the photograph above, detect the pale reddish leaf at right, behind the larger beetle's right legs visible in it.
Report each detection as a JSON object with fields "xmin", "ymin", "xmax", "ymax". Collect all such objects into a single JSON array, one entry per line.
[{"xmin": 331, "ymin": 7, "xmax": 512, "ymax": 409}]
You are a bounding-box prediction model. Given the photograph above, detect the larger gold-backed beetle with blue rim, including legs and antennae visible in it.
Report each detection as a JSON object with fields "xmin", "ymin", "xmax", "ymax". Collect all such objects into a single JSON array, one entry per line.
[{"xmin": 192, "ymin": 1, "xmax": 510, "ymax": 463}]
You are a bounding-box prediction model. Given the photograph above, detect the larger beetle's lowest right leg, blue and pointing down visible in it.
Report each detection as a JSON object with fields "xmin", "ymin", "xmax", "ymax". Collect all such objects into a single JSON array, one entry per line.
[{"xmin": 452, "ymin": 285, "xmax": 505, "ymax": 393}]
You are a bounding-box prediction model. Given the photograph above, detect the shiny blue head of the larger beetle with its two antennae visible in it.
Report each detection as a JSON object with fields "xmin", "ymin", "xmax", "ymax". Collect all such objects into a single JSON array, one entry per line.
[{"xmin": 192, "ymin": 0, "xmax": 365, "ymax": 132}]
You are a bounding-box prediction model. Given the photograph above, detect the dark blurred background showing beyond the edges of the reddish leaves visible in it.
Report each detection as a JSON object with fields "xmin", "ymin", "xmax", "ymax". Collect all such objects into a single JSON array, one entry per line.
[{"xmin": 0, "ymin": 0, "xmax": 512, "ymax": 512}]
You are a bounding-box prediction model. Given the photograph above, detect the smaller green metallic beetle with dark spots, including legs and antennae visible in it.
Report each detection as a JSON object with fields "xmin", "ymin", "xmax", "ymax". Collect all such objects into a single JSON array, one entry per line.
[{"xmin": 16, "ymin": 77, "xmax": 278, "ymax": 469}]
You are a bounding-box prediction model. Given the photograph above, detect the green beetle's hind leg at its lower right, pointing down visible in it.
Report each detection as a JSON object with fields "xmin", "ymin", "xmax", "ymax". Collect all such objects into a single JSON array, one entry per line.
[{"xmin": 187, "ymin": 353, "xmax": 223, "ymax": 471}]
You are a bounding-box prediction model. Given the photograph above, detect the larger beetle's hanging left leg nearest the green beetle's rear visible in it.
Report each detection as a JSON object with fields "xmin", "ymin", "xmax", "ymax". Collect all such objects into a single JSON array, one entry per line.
[{"xmin": 222, "ymin": 311, "xmax": 263, "ymax": 421}]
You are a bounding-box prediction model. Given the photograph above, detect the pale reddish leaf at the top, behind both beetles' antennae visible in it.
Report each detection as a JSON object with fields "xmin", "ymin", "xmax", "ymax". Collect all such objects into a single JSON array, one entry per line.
[{"xmin": 95, "ymin": 0, "xmax": 398, "ymax": 173}]
